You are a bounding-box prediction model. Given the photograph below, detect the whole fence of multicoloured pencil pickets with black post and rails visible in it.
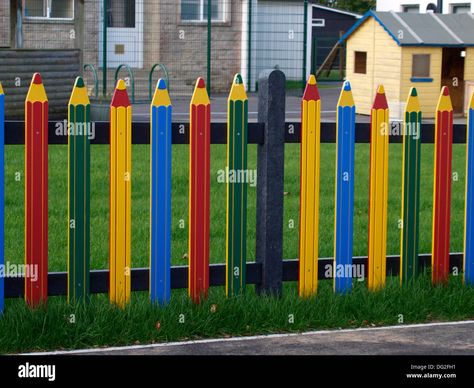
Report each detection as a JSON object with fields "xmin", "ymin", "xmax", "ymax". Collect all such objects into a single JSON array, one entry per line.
[{"xmin": 0, "ymin": 70, "xmax": 474, "ymax": 311}]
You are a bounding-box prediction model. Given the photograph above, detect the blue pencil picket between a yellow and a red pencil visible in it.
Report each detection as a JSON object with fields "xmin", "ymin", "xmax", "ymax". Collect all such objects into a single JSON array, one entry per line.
[{"xmin": 150, "ymin": 79, "xmax": 173, "ymax": 304}]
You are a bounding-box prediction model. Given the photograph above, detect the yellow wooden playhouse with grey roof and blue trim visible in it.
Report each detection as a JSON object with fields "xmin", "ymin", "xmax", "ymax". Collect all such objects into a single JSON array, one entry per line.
[{"xmin": 341, "ymin": 11, "xmax": 474, "ymax": 118}]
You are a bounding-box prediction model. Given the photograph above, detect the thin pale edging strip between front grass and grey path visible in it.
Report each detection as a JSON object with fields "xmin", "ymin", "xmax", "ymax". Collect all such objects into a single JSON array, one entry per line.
[{"xmin": 20, "ymin": 320, "xmax": 474, "ymax": 356}]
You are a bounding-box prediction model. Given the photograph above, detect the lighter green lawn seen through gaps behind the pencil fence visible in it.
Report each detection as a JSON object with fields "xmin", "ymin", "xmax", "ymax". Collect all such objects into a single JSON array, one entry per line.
[{"xmin": 1, "ymin": 144, "xmax": 465, "ymax": 271}]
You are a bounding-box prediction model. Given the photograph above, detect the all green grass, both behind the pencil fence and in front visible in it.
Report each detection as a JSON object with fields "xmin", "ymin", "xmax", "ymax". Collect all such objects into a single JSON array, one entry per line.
[{"xmin": 0, "ymin": 144, "xmax": 474, "ymax": 352}]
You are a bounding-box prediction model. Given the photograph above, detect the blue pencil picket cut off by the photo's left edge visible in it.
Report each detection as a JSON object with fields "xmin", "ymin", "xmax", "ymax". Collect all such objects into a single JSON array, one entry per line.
[{"xmin": 0, "ymin": 83, "xmax": 5, "ymax": 314}]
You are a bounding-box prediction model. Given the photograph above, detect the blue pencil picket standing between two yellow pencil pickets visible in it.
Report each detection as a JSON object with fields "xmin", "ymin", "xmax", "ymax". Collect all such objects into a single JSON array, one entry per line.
[{"xmin": 333, "ymin": 81, "xmax": 356, "ymax": 293}]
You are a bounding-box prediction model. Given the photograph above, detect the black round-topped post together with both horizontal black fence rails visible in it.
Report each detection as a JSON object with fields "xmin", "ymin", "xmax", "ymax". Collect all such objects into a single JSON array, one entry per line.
[{"xmin": 0, "ymin": 70, "xmax": 466, "ymax": 297}]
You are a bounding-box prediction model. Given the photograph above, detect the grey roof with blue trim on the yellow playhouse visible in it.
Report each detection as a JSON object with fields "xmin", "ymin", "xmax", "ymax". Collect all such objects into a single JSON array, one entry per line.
[{"xmin": 340, "ymin": 11, "xmax": 474, "ymax": 47}]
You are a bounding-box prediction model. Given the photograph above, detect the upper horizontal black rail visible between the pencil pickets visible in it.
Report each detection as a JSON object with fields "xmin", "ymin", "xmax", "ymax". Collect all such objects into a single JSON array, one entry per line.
[{"xmin": 1, "ymin": 121, "xmax": 466, "ymax": 145}]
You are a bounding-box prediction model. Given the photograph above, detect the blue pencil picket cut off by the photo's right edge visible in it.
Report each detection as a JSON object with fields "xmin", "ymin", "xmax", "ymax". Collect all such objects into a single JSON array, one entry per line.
[{"xmin": 464, "ymin": 93, "xmax": 474, "ymax": 286}]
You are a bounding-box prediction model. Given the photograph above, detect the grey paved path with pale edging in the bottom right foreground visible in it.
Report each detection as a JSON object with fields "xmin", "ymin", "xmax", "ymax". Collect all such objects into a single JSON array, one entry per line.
[{"xmin": 27, "ymin": 321, "xmax": 474, "ymax": 355}]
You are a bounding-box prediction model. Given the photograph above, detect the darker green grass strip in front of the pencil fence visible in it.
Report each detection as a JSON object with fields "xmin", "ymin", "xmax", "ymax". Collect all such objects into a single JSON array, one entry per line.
[{"xmin": 0, "ymin": 275, "xmax": 474, "ymax": 353}]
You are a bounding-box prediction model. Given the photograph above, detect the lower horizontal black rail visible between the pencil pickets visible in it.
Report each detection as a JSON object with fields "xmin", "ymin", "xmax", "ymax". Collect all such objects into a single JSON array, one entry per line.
[{"xmin": 5, "ymin": 253, "xmax": 463, "ymax": 298}]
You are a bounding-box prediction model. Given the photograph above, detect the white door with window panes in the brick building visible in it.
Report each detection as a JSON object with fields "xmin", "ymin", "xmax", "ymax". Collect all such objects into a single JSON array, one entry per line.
[{"xmin": 99, "ymin": 0, "xmax": 143, "ymax": 68}]
